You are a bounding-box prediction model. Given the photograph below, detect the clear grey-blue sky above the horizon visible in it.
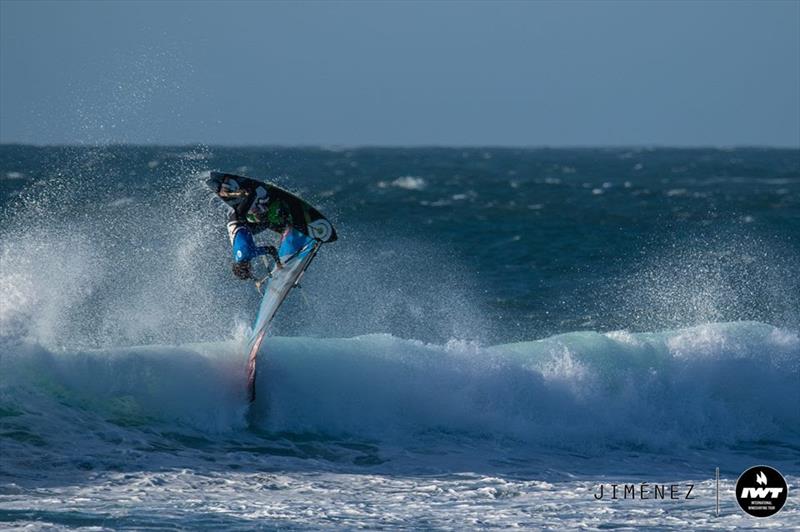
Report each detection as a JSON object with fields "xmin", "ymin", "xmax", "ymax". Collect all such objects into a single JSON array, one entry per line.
[{"xmin": 0, "ymin": 0, "xmax": 800, "ymax": 148}]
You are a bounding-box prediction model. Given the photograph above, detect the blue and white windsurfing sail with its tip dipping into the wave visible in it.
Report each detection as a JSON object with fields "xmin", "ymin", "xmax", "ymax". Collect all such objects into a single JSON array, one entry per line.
[{"xmin": 247, "ymin": 228, "xmax": 322, "ymax": 402}]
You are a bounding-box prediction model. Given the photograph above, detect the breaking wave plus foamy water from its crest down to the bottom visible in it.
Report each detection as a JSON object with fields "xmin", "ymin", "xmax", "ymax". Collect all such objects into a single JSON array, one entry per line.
[{"xmin": 0, "ymin": 314, "xmax": 800, "ymax": 529}]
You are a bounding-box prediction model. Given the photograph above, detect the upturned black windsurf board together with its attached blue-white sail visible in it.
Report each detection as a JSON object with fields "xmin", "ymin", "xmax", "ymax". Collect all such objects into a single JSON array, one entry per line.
[{"xmin": 206, "ymin": 172, "xmax": 337, "ymax": 402}]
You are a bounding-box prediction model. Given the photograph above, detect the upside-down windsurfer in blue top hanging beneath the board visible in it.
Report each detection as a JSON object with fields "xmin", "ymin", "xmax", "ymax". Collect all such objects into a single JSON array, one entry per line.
[{"xmin": 218, "ymin": 180, "xmax": 284, "ymax": 280}]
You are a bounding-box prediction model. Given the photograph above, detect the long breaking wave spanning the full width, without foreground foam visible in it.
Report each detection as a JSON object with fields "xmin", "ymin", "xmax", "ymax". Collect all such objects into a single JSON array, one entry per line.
[{"xmin": 0, "ymin": 322, "xmax": 800, "ymax": 458}]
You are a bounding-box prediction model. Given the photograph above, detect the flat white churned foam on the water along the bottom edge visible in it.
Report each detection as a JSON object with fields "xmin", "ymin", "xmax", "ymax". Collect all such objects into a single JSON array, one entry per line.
[{"xmin": 6, "ymin": 470, "xmax": 799, "ymax": 530}]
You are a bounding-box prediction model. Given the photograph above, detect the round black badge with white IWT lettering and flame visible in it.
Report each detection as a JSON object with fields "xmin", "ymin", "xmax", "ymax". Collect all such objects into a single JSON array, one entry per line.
[{"xmin": 736, "ymin": 466, "xmax": 789, "ymax": 517}]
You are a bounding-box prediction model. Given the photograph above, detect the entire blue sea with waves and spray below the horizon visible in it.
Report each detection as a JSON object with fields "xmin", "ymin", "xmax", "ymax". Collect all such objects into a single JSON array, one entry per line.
[{"xmin": 0, "ymin": 145, "xmax": 800, "ymax": 530}]
